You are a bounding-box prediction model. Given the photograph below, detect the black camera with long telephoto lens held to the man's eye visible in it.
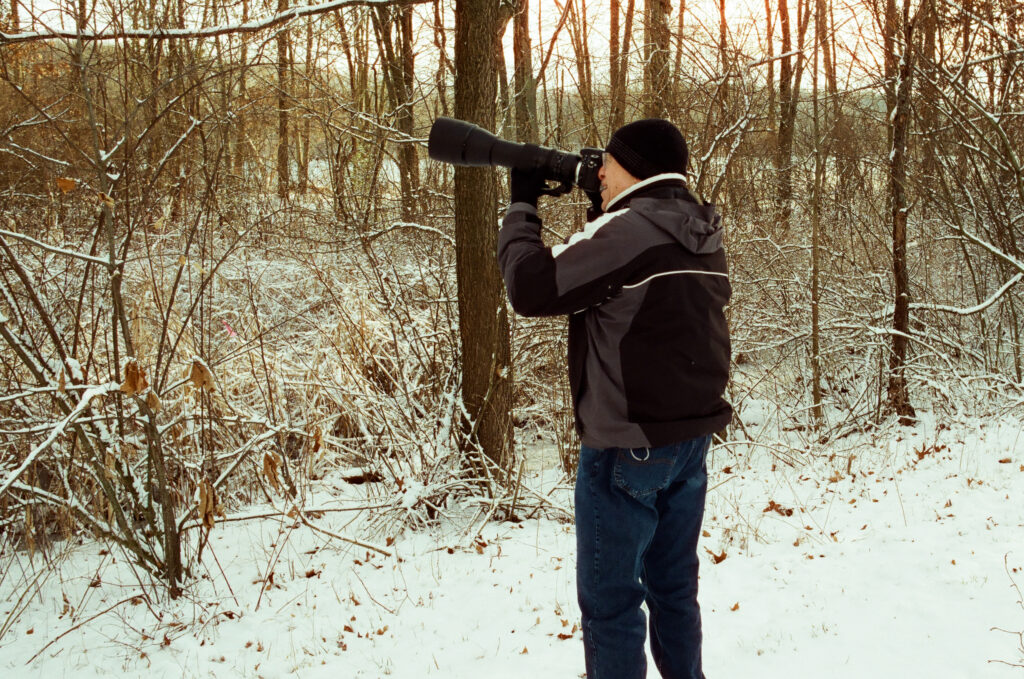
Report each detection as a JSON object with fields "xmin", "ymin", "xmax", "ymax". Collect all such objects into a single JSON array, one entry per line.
[{"xmin": 427, "ymin": 118, "xmax": 604, "ymax": 196}]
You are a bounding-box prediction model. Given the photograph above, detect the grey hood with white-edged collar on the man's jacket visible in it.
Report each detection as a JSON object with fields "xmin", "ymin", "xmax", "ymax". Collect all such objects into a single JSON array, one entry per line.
[{"xmin": 608, "ymin": 174, "xmax": 722, "ymax": 255}]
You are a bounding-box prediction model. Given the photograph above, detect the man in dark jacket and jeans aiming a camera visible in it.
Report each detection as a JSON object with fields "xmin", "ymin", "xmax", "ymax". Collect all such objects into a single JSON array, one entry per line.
[{"xmin": 498, "ymin": 119, "xmax": 732, "ymax": 679}]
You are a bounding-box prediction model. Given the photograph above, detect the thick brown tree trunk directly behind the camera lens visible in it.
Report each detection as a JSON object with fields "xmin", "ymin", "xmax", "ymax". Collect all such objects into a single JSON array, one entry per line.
[{"xmin": 455, "ymin": 0, "xmax": 515, "ymax": 467}]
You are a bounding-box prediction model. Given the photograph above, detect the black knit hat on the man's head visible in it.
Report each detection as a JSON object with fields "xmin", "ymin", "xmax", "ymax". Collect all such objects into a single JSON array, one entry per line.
[{"xmin": 605, "ymin": 118, "xmax": 690, "ymax": 179}]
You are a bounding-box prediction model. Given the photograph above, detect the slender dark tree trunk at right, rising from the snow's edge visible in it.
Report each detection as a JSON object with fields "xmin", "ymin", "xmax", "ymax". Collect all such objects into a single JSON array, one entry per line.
[{"xmin": 885, "ymin": 0, "xmax": 915, "ymax": 425}]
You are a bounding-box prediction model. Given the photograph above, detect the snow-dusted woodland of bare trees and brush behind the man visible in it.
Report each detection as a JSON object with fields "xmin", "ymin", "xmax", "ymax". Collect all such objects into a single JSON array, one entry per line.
[{"xmin": 0, "ymin": 0, "xmax": 1024, "ymax": 610}]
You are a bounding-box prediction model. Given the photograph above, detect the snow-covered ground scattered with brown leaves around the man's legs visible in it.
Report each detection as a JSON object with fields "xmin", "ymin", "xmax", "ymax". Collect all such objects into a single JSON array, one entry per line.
[{"xmin": 0, "ymin": 419, "xmax": 1024, "ymax": 679}]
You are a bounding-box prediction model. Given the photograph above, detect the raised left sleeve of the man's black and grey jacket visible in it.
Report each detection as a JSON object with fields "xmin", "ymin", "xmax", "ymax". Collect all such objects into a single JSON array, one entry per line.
[{"xmin": 498, "ymin": 203, "xmax": 636, "ymax": 316}]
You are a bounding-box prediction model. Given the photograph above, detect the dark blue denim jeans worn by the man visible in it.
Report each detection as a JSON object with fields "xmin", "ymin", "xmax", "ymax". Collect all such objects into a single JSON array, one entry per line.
[{"xmin": 575, "ymin": 436, "xmax": 711, "ymax": 679}]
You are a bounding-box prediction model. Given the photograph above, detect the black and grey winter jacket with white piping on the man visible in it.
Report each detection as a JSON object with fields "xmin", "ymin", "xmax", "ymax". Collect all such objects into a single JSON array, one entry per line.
[{"xmin": 498, "ymin": 174, "xmax": 732, "ymax": 449}]
